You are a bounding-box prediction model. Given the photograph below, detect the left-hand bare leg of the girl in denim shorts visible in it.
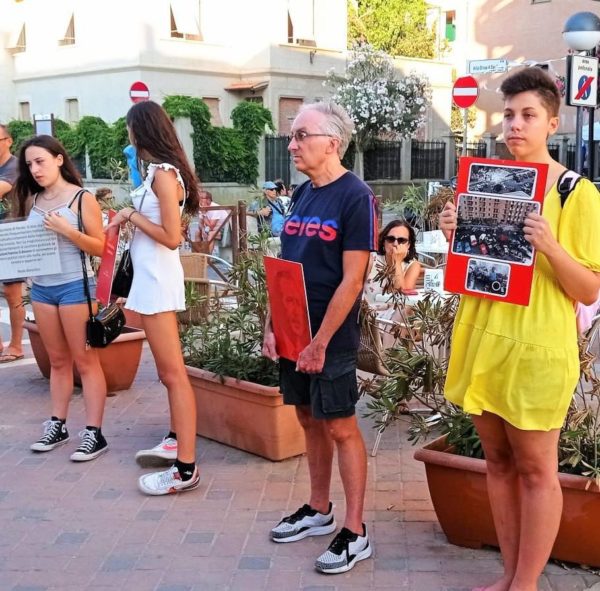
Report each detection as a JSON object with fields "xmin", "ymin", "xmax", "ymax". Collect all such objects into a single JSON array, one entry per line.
[{"xmin": 32, "ymin": 302, "xmax": 73, "ymax": 419}]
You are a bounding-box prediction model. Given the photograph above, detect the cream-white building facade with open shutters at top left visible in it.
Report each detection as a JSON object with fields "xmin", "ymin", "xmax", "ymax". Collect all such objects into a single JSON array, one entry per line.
[{"xmin": 0, "ymin": 0, "xmax": 452, "ymax": 138}]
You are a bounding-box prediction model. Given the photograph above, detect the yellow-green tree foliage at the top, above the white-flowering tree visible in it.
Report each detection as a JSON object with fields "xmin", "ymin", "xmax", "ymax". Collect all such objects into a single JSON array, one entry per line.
[{"xmin": 348, "ymin": 0, "xmax": 436, "ymax": 59}]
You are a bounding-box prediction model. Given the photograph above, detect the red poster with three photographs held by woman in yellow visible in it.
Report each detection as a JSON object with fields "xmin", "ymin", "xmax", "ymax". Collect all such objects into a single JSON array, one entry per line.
[{"xmin": 444, "ymin": 157, "xmax": 548, "ymax": 306}]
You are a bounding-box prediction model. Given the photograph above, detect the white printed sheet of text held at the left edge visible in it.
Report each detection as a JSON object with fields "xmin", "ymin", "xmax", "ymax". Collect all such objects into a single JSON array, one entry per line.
[{"xmin": 0, "ymin": 221, "xmax": 61, "ymax": 281}]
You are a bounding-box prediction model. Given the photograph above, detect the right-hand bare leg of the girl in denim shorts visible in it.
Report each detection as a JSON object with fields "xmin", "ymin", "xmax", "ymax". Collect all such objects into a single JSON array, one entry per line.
[{"xmin": 58, "ymin": 304, "xmax": 106, "ymax": 427}]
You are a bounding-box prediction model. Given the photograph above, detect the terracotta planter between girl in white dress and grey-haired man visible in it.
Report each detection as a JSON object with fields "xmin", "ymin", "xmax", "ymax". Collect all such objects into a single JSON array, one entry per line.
[{"xmin": 187, "ymin": 366, "xmax": 306, "ymax": 461}]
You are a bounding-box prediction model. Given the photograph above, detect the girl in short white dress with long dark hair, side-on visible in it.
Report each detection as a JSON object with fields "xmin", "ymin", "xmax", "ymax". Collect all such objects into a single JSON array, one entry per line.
[{"xmin": 107, "ymin": 101, "xmax": 200, "ymax": 495}]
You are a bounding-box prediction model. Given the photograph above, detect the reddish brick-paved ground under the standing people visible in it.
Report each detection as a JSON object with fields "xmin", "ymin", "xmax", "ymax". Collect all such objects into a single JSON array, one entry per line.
[{"xmin": 0, "ymin": 336, "xmax": 600, "ymax": 591}]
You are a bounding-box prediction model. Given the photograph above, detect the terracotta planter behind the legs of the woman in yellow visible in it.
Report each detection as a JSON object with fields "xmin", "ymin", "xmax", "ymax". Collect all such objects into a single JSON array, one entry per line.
[{"xmin": 415, "ymin": 437, "xmax": 600, "ymax": 566}]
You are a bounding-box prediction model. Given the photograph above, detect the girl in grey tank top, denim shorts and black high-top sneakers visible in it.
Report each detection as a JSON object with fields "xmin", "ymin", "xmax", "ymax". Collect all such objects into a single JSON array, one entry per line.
[{"xmin": 15, "ymin": 135, "xmax": 108, "ymax": 462}]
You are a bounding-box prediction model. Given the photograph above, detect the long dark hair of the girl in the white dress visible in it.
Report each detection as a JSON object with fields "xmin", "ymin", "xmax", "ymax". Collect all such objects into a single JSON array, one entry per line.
[{"xmin": 127, "ymin": 101, "xmax": 199, "ymax": 215}]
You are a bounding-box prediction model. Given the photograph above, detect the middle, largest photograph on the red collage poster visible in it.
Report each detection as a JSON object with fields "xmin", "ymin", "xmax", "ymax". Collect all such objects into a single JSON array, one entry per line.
[{"xmin": 452, "ymin": 193, "xmax": 540, "ymax": 265}]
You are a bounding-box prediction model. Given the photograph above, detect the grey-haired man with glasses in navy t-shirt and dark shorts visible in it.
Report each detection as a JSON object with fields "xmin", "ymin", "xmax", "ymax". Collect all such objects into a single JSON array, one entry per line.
[{"xmin": 263, "ymin": 102, "xmax": 377, "ymax": 574}]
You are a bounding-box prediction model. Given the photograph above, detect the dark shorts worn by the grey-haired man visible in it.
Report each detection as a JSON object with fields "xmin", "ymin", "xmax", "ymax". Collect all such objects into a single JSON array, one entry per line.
[{"xmin": 279, "ymin": 350, "xmax": 358, "ymax": 419}]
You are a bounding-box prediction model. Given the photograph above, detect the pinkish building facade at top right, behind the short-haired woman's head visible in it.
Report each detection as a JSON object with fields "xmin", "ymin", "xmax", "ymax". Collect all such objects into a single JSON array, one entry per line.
[{"xmin": 429, "ymin": 0, "xmax": 600, "ymax": 135}]
